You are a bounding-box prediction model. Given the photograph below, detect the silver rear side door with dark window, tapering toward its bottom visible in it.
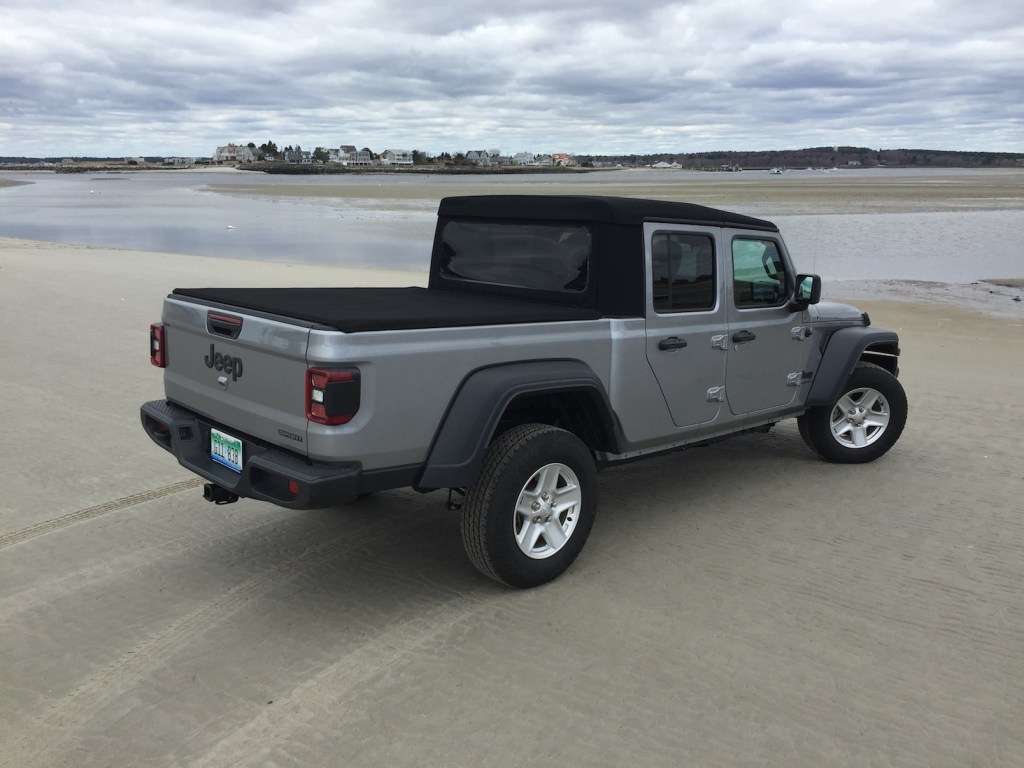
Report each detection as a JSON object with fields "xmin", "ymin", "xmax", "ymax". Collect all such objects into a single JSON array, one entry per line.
[{"xmin": 644, "ymin": 223, "xmax": 728, "ymax": 427}]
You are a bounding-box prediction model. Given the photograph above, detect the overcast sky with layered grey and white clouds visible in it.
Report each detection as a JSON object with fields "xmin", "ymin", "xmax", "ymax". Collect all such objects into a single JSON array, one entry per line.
[{"xmin": 0, "ymin": 0, "xmax": 1024, "ymax": 156}]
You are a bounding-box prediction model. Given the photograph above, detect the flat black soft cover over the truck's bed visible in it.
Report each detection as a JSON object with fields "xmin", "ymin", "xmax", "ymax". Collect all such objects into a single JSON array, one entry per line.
[{"xmin": 172, "ymin": 287, "xmax": 602, "ymax": 333}]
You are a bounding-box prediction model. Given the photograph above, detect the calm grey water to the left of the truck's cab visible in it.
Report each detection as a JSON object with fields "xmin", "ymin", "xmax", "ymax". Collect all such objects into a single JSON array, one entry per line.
[{"xmin": 0, "ymin": 172, "xmax": 436, "ymax": 268}]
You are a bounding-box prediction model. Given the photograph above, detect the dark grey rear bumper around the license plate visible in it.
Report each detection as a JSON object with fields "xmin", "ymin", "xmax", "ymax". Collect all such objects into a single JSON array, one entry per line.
[{"xmin": 140, "ymin": 400, "xmax": 419, "ymax": 509}]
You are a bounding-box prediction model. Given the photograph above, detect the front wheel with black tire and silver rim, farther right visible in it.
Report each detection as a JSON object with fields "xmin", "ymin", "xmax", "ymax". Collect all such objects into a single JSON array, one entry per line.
[{"xmin": 798, "ymin": 362, "xmax": 907, "ymax": 464}]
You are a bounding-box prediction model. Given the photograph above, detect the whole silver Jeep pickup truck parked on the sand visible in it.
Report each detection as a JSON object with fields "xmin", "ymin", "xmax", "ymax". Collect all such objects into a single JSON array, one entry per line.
[{"xmin": 141, "ymin": 196, "xmax": 907, "ymax": 587}]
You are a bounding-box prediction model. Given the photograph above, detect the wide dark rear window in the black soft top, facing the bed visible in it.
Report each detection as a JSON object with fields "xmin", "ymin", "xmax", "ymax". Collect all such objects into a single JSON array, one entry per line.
[{"xmin": 439, "ymin": 221, "xmax": 591, "ymax": 293}]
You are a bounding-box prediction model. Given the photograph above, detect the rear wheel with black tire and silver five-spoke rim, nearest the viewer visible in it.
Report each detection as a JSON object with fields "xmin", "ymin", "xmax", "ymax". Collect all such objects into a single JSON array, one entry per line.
[{"xmin": 462, "ymin": 424, "xmax": 597, "ymax": 588}]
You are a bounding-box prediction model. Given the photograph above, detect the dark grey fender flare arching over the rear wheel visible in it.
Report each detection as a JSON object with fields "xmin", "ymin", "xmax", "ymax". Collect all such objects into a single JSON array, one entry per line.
[{"xmin": 416, "ymin": 359, "xmax": 620, "ymax": 490}]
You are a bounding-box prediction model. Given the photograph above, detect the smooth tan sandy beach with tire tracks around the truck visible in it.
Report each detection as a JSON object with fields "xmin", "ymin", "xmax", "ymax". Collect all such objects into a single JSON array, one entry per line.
[{"xmin": 0, "ymin": 231, "xmax": 1024, "ymax": 768}]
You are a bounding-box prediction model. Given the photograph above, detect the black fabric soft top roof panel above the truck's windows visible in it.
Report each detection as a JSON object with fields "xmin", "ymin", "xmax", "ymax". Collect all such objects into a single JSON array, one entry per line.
[{"xmin": 437, "ymin": 195, "xmax": 778, "ymax": 231}]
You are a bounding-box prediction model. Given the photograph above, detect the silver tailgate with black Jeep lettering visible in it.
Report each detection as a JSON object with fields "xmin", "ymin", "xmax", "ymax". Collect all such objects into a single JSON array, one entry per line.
[{"xmin": 163, "ymin": 298, "xmax": 309, "ymax": 455}]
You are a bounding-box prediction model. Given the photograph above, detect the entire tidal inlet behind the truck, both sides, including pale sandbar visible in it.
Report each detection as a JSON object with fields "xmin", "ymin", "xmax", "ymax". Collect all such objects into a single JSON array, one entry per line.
[{"xmin": 0, "ymin": 170, "xmax": 1024, "ymax": 283}]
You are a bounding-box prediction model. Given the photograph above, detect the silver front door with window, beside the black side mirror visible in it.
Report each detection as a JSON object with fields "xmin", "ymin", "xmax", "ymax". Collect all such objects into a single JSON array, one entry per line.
[{"xmin": 725, "ymin": 233, "xmax": 803, "ymax": 416}]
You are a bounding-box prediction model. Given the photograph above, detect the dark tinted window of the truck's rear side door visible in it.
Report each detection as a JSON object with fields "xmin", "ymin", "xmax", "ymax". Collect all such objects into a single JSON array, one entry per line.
[{"xmin": 650, "ymin": 232, "xmax": 716, "ymax": 312}]
